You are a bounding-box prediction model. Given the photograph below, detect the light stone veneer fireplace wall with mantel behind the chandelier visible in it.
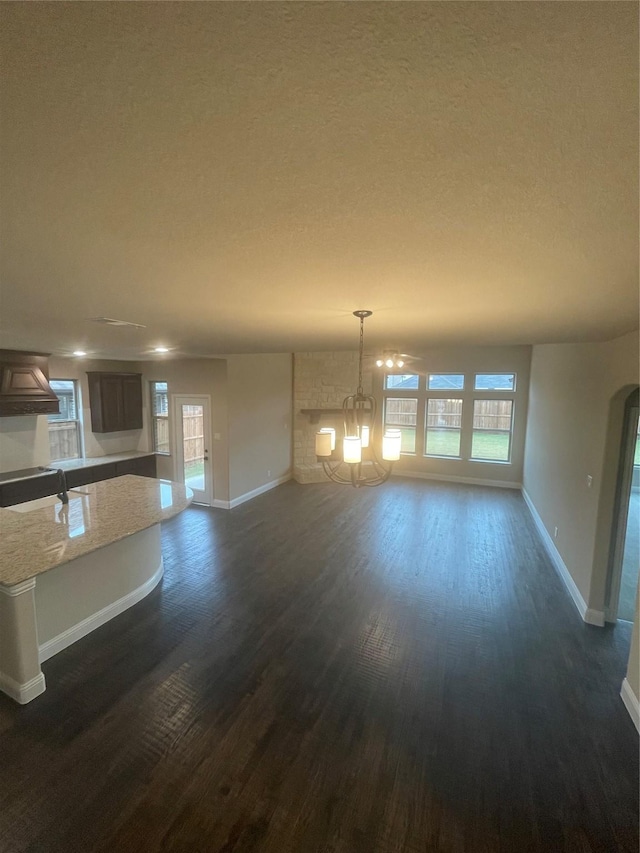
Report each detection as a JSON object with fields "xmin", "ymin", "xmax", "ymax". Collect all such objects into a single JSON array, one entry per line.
[{"xmin": 293, "ymin": 352, "xmax": 371, "ymax": 483}]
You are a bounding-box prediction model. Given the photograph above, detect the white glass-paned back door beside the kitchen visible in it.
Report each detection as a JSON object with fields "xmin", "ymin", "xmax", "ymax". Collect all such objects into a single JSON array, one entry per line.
[{"xmin": 172, "ymin": 394, "xmax": 213, "ymax": 506}]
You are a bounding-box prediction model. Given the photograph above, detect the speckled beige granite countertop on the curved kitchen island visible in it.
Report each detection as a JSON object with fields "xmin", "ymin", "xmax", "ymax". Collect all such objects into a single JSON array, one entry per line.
[{"xmin": 0, "ymin": 472, "xmax": 193, "ymax": 586}]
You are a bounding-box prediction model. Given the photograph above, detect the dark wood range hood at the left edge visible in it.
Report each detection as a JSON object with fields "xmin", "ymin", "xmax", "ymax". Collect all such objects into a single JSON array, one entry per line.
[{"xmin": 0, "ymin": 349, "xmax": 60, "ymax": 418}]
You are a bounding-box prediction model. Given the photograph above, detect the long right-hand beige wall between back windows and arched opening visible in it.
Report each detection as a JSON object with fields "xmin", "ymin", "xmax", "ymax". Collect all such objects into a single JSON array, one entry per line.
[{"xmin": 523, "ymin": 332, "xmax": 638, "ymax": 610}]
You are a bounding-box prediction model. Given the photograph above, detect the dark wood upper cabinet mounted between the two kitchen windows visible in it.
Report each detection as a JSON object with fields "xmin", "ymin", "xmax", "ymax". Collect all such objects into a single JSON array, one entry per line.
[{"xmin": 87, "ymin": 372, "xmax": 142, "ymax": 432}]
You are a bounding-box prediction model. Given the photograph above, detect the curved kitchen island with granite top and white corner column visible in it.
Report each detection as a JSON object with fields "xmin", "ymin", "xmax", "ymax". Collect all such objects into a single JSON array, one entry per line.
[{"xmin": 0, "ymin": 475, "xmax": 193, "ymax": 704}]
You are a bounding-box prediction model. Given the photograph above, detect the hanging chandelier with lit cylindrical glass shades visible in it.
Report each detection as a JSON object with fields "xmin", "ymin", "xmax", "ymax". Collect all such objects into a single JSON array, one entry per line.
[{"xmin": 316, "ymin": 311, "xmax": 402, "ymax": 488}]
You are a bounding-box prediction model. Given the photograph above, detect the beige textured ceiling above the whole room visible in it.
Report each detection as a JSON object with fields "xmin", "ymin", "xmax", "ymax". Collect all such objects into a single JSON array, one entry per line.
[{"xmin": 0, "ymin": 2, "xmax": 638, "ymax": 358}]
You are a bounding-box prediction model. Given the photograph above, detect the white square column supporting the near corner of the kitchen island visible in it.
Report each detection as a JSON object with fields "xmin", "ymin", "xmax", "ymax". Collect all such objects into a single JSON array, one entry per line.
[{"xmin": 0, "ymin": 578, "xmax": 46, "ymax": 705}]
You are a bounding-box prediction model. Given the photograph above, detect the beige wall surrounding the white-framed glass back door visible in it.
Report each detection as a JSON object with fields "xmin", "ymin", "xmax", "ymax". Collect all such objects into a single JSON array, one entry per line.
[{"xmin": 136, "ymin": 358, "xmax": 229, "ymax": 503}]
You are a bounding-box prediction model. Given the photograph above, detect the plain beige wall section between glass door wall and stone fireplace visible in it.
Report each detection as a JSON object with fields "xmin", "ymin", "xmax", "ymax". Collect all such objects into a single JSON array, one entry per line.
[{"xmin": 226, "ymin": 353, "xmax": 293, "ymax": 502}]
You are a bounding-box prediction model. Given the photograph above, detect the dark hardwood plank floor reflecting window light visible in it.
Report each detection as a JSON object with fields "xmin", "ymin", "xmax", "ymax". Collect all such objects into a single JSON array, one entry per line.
[{"xmin": 0, "ymin": 480, "xmax": 639, "ymax": 853}]
